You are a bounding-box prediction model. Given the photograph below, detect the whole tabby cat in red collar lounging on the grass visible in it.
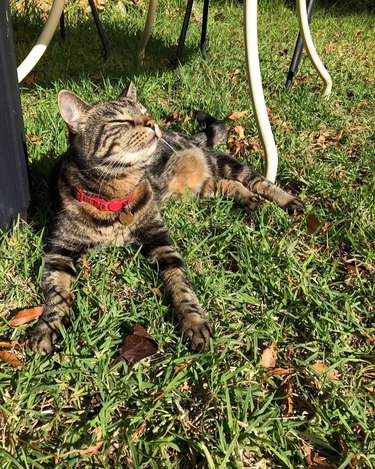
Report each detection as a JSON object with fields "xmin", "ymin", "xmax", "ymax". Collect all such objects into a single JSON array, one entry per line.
[{"xmin": 30, "ymin": 83, "xmax": 302, "ymax": 354}]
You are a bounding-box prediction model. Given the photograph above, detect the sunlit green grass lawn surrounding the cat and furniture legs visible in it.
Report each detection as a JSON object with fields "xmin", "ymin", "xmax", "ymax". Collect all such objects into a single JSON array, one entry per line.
[{"xmin": 0, "ymin": 0, "xmax": 375, "ymax": 468}]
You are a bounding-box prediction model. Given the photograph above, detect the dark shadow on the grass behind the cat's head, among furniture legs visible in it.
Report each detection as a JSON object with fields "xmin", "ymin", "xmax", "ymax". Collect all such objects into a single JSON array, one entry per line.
[{"xmin": 12, "ymin": 8, "xmax": 203, "ymax": 88}]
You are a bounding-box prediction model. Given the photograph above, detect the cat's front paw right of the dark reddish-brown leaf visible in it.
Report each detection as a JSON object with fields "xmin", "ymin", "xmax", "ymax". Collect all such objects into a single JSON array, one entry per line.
[{"xmin": 181, "ymin": 313, "xmax": 211, "ymax": 352}]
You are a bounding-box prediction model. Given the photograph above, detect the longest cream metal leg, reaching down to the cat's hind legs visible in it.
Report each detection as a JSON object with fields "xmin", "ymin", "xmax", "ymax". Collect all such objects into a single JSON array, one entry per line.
[{"xmin": 244, "ymin": 0, "xmax": 278, "ymax": 182}]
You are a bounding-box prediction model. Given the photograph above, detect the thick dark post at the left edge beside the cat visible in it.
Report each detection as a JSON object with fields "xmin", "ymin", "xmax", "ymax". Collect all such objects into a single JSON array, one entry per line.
[{"xmin": 0, "ymin": 0, "xmax": 30, "ymax": 230}]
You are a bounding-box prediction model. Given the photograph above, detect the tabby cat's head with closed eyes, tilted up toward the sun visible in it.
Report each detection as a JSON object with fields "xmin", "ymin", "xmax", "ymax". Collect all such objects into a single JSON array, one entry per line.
[{"xmin": 58, "ymin": 82, "xmax": 161, "ymax": 168}]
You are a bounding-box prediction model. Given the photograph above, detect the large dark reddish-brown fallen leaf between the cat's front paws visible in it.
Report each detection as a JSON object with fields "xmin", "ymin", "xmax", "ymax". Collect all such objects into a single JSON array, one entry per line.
[{"xmin": 114, "ymin": 324, "xmax": 158, "ymax": 365}]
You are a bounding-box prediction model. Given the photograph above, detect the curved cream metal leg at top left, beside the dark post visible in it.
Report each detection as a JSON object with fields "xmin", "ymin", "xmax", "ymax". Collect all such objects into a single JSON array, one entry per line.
[{"xmin": 17, "ymin": 0, "xmax": 64, "ymax": 82}]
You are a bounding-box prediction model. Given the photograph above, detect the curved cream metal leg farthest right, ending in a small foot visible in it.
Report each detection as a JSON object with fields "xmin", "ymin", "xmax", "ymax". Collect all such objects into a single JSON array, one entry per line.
[{"xmin": 297, "ymin": 0, "xmax": 332, "ymax": 98}]
